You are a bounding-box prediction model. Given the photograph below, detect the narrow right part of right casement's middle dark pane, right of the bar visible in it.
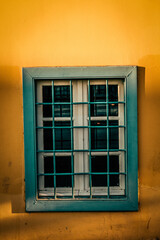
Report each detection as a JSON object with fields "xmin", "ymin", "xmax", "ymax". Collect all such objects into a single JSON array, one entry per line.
[{"xmin": 109, "ymin": 120, "xmax": 119, "ymax": 149}]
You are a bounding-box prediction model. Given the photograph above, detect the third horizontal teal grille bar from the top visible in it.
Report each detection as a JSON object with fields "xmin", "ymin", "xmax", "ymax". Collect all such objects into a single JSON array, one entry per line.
[{"xmin": 37, "ymin": 149, "xmax": 126, "ymax": 153}]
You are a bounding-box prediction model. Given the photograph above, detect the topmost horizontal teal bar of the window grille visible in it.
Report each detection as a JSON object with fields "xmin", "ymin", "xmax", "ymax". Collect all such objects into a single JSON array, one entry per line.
[{"xmin": 36, "ymin": 101, "xmax": 125, "ymax": 105}]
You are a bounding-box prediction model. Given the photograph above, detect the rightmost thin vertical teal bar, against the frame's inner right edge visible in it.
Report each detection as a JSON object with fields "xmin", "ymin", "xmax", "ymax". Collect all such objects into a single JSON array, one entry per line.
[{"xmin": 124, "ymin": 78, "xmax": 128, "ymax": 196}]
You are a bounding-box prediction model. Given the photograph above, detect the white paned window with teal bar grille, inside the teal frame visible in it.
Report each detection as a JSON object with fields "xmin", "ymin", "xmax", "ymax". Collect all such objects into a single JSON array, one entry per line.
[{"xmin": 35, "ymin": 79, "xmax": 127, "ymax": 199}]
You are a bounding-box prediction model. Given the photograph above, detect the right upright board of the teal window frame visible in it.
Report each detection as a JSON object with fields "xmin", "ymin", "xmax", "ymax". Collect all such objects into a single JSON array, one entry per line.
[{"xmin": 126, "ymin": 68, "xmax": 138, "ymax": 209}]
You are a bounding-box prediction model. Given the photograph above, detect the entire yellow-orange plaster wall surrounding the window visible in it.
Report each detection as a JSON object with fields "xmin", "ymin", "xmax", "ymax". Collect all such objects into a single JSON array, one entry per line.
[{"xmin": 0, "ymin": 0, "xmax": 160, "ymax": 240}]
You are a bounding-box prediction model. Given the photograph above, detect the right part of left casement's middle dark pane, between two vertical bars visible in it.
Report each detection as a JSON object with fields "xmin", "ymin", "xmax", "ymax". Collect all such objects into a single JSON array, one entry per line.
[{"xmin": 55, "ymin": 121, "xmax": 71, "ymax": 150}]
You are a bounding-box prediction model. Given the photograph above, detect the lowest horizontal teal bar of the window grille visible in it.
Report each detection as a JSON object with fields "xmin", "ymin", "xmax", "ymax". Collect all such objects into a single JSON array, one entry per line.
[{"xmin": 37, "ymin": 172, "xmax": 127, "ymax": 176}]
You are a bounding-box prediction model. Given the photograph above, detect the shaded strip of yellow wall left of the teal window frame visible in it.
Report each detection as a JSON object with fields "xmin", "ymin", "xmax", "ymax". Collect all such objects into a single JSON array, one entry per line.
[{"xmin": 0, "ymin": 66, "xmax": 24, "ymax": 212}]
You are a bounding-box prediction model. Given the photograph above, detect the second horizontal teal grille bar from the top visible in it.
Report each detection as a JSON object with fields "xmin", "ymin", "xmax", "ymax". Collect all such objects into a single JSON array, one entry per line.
[{"xmin": 36, "ymin": 125, "xmax": 126, "ymax": 129}]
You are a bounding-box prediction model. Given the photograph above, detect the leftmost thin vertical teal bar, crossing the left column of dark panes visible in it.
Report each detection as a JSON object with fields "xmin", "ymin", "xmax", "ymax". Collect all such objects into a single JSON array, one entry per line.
[{"xmin": 52, "ymin": 80, "xmax": 56, "ymax": 199}]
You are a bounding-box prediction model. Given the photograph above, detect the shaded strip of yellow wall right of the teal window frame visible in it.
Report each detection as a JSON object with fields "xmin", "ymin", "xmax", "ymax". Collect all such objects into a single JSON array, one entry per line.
[{"xmin": 138, "ymin": 55, "xmax": 160, "ymax": 187}]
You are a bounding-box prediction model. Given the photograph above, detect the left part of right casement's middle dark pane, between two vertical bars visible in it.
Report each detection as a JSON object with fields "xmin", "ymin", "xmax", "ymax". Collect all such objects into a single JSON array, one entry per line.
[{"xmin": 91, "ymin": 121, "xmax": 107, "ymax": 149}]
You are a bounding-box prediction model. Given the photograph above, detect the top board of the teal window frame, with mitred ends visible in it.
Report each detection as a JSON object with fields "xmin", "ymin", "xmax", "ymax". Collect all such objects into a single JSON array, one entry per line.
[{"xmin": 25, "ymin": 66, "xmax": 134, "ymax": 79}]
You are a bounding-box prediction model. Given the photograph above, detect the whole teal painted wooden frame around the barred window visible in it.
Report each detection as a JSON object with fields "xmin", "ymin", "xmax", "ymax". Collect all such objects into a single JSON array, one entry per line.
[{"xmin": 23, "ymin": 66, "xmax": 138, "ymax": 212}]
